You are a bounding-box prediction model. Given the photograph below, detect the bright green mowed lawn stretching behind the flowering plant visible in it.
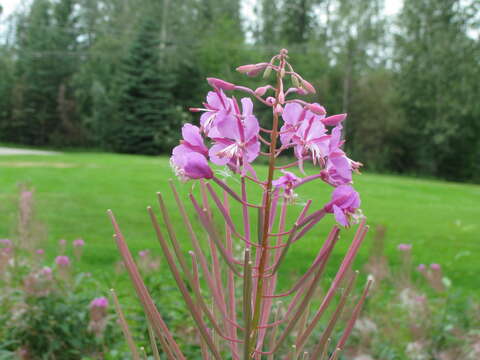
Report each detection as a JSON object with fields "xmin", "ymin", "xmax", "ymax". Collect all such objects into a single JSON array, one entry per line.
[{"xmin": 0, "ymin": 153, "xmax": 480, "ymax": 294}]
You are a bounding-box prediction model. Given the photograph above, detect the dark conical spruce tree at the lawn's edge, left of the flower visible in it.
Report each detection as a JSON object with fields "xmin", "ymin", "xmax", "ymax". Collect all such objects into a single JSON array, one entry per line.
[{"xmin": 112, "ymin": 17, "xmax": 180, "ymax": 154}]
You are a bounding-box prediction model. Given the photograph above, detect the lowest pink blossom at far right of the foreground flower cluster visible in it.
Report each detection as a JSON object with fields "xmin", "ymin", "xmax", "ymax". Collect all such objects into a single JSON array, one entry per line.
[{"xmin": 325, "ymin": 185, "xmax": 360, "ymax": 226}]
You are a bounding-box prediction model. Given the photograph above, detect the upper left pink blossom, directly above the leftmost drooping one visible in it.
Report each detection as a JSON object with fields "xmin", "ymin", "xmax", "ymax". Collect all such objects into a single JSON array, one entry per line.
[{"xmin": 194, "ymin": 90, "xmax": 234, "ymax": 135}]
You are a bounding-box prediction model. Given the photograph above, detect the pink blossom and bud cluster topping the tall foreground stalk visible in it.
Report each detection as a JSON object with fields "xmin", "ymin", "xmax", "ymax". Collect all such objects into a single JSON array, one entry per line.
[{"xmin": 170, "ymin": 50, "xmax": 362, "ymax": 226}]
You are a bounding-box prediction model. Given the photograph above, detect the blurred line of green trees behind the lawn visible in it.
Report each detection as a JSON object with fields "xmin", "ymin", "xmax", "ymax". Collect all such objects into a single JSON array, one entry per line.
[{"xmin": 0, "ymin": 0, "xmax": 480, "ymax": 182}]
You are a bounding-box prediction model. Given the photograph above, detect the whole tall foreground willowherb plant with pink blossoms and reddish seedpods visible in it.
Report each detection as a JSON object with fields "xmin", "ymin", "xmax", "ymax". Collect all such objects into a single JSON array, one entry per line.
[{"xmin": 109, "ymin": 50, "xmax": 372, "ymax": 360}]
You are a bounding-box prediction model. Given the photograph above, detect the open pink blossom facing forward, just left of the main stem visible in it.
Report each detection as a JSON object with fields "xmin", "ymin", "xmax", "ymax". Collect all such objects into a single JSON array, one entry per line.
[{"xmin": 209, "ymin": 98, "xmax": 260, "ymax": 171}]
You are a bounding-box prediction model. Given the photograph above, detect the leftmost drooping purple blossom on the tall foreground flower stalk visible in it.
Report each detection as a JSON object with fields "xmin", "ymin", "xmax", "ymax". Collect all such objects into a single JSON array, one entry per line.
[{"xmin": 170, "ymin": 124, "xmax": 213, "ymax": 181}]
